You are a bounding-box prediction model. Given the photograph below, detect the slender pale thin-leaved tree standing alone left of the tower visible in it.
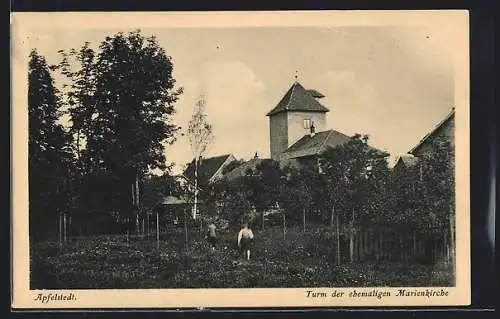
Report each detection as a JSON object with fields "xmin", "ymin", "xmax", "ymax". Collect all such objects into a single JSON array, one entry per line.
[{"xmin": 187, "ymin": 95, "xmax": 215, "ymax": 219}]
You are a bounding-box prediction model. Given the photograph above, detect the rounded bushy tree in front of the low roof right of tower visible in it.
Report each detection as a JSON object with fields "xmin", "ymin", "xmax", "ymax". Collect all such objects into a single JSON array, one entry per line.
[{"xmin": 319, "ymin": 134, "xmax": 389, "ymax": 262}]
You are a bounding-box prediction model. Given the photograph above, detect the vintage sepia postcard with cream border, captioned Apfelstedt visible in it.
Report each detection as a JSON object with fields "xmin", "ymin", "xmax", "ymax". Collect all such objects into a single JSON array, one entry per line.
[{"xmin": 11, "ymin": 10, "xmax": 471, "ymax": 309}]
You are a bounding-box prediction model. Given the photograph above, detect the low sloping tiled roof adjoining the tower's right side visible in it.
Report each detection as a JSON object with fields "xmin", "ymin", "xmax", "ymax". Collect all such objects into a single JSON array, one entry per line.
[{"xmin": 284, "ymin": 130, "xmax": 388, "ymax": 158}]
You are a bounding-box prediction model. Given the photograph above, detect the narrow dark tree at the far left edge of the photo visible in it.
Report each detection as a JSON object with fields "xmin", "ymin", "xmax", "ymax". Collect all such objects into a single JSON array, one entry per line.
[{"xmin": 28, "ymin": 50, "xmax": 73, "ymax": 238}]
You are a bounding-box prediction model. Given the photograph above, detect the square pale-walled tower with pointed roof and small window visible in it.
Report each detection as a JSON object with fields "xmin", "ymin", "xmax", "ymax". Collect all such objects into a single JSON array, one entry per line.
[{"xmin": 267, "ymin": 81, "xmax": 329, "ymax": 160}]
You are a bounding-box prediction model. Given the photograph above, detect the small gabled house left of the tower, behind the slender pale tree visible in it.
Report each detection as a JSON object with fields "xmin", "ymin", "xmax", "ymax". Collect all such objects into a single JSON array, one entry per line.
[{"xmin": 183, "ymin": 154, "xmax": 236, "ymax": 187}]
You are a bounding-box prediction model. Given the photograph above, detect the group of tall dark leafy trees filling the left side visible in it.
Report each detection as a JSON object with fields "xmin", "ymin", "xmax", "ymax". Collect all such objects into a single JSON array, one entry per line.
[{"xmin": 29, "ymin": 31, "xmax": 182, "ymax": 240}]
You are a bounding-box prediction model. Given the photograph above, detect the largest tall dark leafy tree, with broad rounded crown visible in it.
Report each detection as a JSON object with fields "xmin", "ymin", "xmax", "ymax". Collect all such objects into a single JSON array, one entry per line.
[{"xmin": 59, "ymin": 31, "xmax": 182, "ymax": 235}]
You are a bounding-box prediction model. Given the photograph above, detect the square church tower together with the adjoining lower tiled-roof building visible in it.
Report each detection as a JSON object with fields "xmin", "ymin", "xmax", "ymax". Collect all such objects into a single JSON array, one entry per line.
[{"xmin": 266, "ymin": 81, "xmax": 389, "ymax": 166}]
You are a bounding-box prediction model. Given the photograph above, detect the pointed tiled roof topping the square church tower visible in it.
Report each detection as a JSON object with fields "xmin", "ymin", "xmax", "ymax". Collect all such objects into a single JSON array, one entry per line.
[{"xmin": 267, "ymin": 82, "xmax": 330, "ymax": 116}]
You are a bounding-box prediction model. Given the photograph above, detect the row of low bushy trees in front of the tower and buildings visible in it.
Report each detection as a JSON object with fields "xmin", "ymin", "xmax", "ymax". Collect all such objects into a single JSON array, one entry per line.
[{"xmin": 201, "ymin": 135, "xmax": 455, "ymax": 262}]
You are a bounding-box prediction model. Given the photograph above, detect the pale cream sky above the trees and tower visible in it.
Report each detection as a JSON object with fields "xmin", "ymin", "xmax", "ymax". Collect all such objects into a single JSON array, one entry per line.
[{"xmin": 21, "ymin": 22, "xmax": 454, "ymax": 172}]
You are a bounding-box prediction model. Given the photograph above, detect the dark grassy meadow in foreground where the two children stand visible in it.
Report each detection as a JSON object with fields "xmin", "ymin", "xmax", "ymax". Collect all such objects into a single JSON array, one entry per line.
[{"xmin": 30, "ymin": 229, "xmax": 451, "ymax": 289}]
